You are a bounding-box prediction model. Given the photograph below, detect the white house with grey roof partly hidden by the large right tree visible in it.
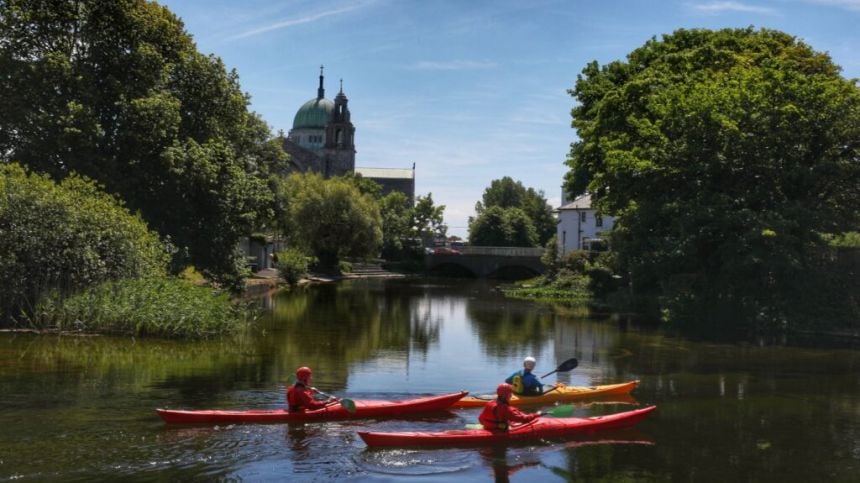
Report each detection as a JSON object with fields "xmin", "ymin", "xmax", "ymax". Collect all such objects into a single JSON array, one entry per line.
[{"xmin": 556, "ymin": 194, "xmax": 613, "ymax": 255}]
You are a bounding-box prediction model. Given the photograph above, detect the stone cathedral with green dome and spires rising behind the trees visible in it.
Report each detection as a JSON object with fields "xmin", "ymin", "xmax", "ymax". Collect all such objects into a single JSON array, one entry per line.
[{"xmin": 284, "ymin": 67, "xmax": 415, "ymax": 205}]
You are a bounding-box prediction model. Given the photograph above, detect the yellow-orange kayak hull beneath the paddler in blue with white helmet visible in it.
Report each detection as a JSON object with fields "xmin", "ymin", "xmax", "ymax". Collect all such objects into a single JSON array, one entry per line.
[{"xmin": 451, "ymin": 381, "xmax": 639, "ymax": 408}]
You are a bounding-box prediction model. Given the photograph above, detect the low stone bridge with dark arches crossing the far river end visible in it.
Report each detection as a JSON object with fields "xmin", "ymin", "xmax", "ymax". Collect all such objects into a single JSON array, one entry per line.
[{"xmin": 424, "ymin": 246, "xmax": 546, "ymax": 279}]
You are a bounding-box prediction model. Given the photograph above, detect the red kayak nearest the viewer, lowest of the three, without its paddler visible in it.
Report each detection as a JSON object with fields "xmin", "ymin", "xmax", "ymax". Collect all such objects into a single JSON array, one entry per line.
[{"xmin": 358, "ymin": 406, "xmax": 657, "ymax": 447}]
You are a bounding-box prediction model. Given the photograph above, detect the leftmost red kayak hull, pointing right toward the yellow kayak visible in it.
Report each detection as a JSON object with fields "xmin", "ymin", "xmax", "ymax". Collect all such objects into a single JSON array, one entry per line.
[{"xmin": 157, "ymin": 391, "xmax": 468, "ymax": 424}]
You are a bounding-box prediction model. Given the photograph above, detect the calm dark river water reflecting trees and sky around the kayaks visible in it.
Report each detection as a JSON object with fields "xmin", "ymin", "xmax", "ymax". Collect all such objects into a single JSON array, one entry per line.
[{"xmin": 0, "ymin": 280, "xmax": 860, "ymax": 482}]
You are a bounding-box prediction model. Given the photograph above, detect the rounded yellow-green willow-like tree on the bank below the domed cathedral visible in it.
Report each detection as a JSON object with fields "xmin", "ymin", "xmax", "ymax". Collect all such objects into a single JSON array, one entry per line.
[{"xmin": 282, "ymin": 173, "xmax": 382, "ymax": 269}]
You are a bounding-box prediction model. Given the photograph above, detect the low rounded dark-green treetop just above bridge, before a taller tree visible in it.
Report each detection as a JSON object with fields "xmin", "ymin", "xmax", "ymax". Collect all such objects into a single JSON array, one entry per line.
[{"xmin": 469, "ymin": 206, "xmax": 538, "ymax": 247}]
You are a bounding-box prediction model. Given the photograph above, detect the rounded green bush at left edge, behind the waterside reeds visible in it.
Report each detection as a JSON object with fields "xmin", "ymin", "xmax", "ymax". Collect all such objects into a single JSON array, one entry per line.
[{"xmin": 0, "ymin": 164, "xmax": 168, "ymax": 322}]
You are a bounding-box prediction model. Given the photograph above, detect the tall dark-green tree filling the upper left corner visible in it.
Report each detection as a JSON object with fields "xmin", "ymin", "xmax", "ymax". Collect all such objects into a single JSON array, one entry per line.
[{"xmin": 0, "ymin": 0, "xmax": 286, "ymax": 285}]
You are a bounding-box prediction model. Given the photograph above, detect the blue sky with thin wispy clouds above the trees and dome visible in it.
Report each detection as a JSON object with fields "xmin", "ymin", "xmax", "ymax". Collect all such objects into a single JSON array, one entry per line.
[{"xmin": 161, "ymin": 0, "xmax": 860, "ymax": 237}]
